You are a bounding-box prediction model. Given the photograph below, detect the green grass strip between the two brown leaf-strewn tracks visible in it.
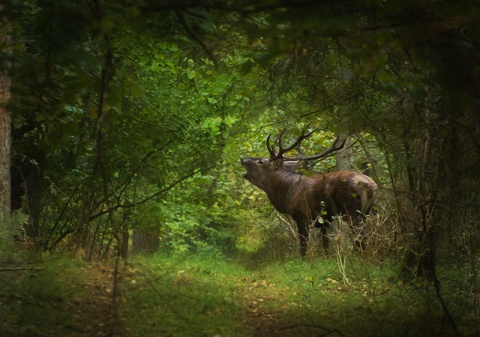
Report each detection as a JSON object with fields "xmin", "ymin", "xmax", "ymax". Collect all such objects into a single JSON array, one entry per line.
[{"xmin": 121, "ymin": 255, "xmax": 249, "ymax": 336}]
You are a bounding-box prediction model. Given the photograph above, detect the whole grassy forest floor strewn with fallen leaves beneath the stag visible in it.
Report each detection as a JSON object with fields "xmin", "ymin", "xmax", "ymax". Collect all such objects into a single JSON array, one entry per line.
[{"xmin": 0, "ymin": 254, "xmax": 480, "ymax": 337}]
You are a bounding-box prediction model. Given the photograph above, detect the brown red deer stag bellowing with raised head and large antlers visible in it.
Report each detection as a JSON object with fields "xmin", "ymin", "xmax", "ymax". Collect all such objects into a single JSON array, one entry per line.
[{"xmin": 240, "ymin": 130, "xmax": 377, "ymax": 257}]
